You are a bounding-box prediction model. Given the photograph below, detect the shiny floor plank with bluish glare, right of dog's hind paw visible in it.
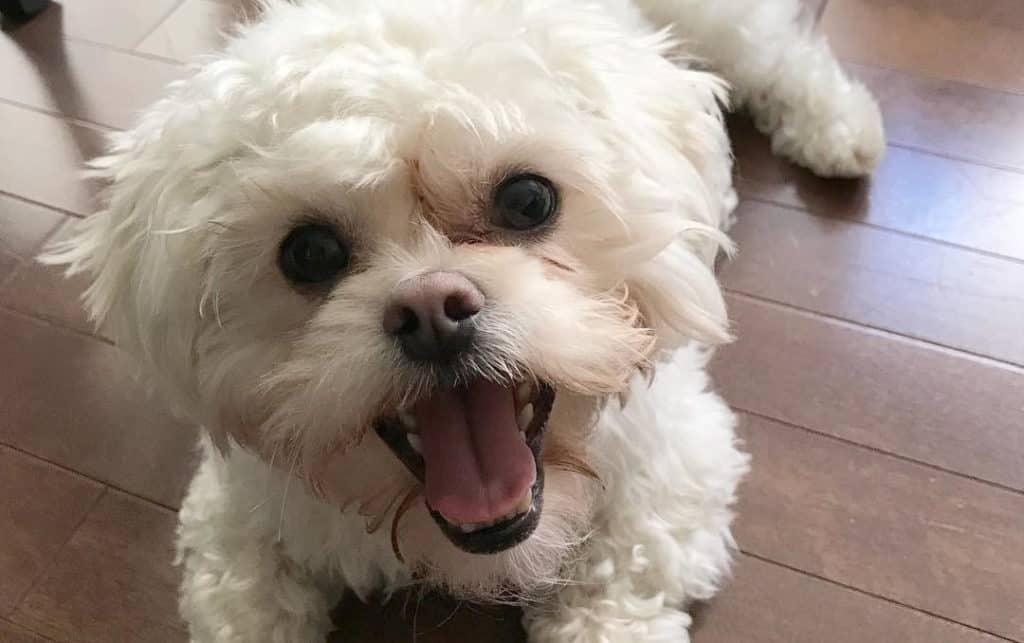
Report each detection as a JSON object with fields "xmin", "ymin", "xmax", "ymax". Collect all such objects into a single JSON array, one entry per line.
[{"xmin": 847, "ymin": 63, "xmax": 1024, "ymax": 170}]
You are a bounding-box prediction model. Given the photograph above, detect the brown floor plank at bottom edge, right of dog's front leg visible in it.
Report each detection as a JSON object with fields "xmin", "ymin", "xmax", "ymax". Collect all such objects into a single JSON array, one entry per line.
[{"xmin": 692, "ymin": 556, "xmax": 1001, "ymax": 643}]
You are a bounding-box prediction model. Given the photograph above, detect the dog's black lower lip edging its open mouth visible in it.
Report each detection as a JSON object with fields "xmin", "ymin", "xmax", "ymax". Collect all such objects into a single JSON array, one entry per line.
[{"xmin": 374, "ymin": 382, "xmax": 555, "ymax": 554}]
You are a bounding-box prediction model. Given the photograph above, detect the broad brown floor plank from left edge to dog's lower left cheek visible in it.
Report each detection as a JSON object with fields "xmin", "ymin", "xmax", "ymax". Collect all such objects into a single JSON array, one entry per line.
[{"xmin": 0, "ymin": 310, "xmax": 196, "ymax": 506}]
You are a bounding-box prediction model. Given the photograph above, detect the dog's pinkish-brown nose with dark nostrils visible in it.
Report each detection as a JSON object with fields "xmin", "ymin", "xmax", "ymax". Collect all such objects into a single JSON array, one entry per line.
[{"xmin": 384, "ymin": 271, "xmax": 485, "ymax": 361}]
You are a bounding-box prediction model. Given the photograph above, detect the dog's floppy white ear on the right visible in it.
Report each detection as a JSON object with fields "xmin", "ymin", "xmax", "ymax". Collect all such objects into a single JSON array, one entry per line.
[{"xmin": 614, "ymin": 57, "xmax": 737, "ymax": 348}]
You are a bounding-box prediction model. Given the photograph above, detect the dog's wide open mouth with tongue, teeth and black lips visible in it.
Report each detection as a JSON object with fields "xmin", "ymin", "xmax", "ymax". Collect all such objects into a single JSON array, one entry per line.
[{"xmin": 375, "ymin": 380, "xmax": 555, "ymax": 554}]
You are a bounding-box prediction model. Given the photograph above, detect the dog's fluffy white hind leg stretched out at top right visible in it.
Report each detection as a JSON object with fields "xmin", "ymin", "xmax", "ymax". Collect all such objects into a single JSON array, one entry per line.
[{"xmin": 637, "ymin": 0, "xmax": 885, "ymax": 176}]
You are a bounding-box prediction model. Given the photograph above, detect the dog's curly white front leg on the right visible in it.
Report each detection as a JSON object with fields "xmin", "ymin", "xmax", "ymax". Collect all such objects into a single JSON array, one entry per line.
[{"xmin": 525, "ymin": 349, "xmax": 748, "ymax": 643}]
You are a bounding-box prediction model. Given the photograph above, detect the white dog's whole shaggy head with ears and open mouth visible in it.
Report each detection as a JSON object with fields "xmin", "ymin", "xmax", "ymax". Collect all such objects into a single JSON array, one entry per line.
[{"xmin": 51, "ymin": 0, "xmax": 727, "ymax": 594}]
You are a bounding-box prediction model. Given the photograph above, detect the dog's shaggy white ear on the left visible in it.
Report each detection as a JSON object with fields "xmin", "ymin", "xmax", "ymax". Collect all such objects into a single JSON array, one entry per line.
[{"xmin": 39, "ymin": 123, "xmax": 212, "ymax": 419}]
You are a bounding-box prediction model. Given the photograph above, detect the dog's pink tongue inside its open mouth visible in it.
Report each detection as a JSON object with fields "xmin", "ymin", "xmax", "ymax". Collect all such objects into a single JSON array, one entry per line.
[{"xmin": 414, "ymin": 381, "xmax": 537, "ymax": 523}]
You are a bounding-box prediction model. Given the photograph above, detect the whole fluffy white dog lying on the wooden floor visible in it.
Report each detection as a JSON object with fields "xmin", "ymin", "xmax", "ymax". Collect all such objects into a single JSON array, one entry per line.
[{"xmin": 49, "ymin": 0, "xmax": 884, "ymax": 643}]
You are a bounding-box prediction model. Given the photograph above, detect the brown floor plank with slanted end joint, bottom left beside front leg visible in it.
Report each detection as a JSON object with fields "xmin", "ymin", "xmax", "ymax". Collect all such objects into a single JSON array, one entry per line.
[{"xmin": 11, "ymin": 490, "xmax": 188, "ymax": 643}]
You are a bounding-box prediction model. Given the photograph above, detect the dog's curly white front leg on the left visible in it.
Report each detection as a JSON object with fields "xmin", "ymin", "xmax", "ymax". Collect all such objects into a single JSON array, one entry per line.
[{"xmin": 178, "ymin": 448, "xmax": 331, "ymax": 643}]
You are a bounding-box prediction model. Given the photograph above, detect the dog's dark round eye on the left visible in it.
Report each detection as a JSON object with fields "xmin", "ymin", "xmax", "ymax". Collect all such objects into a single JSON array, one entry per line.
[{"xmin": 278, "ymin": 223, "xmax": 349, "ymax": 284}]
